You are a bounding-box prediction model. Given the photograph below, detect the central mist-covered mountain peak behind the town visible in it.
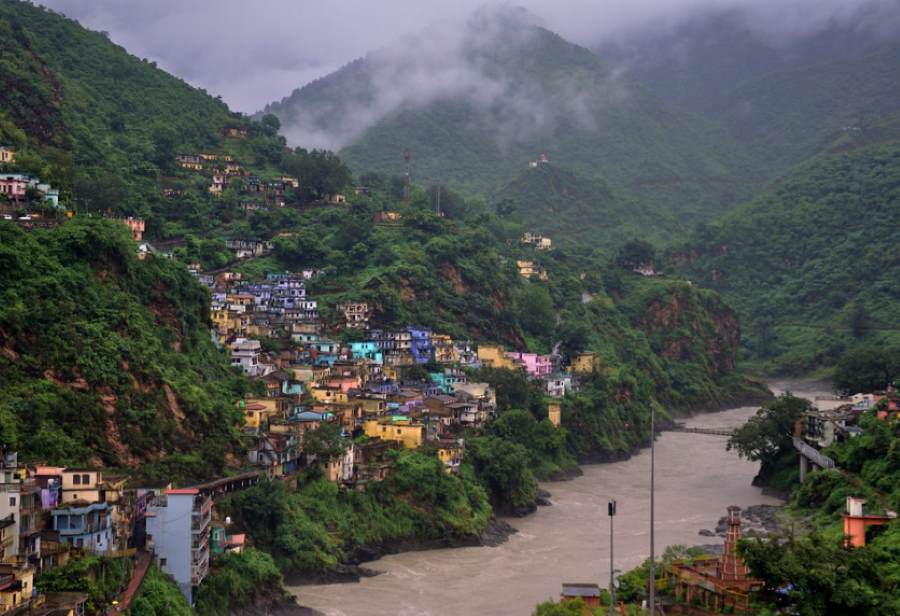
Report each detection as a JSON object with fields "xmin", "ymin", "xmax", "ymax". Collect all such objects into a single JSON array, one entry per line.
[{"xmin": 265, "ymin": 10, "xmax": 752, "ymax": 231}]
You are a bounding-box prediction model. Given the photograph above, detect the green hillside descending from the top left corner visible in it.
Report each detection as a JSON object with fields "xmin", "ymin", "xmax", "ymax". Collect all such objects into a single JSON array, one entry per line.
[{"xmin": 0, "ymin": 0, "xmax": 320, "ymax": 239}]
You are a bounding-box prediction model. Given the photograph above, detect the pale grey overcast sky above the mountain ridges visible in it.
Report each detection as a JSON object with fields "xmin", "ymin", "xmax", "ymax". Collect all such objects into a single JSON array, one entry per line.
[{"xmin": 40, "ymin": 0, "xmax": 884, "ymax": 113}]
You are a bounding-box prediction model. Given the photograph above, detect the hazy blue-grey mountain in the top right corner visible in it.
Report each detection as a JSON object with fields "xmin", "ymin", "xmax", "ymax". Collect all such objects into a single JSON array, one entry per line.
[{"xmin": 597, "ymin": 2, "xmax": 900, "ymax": 178}]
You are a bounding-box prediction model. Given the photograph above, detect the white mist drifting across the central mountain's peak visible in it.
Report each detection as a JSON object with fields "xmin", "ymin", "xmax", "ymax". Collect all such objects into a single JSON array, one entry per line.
[{"xmin": 267, "ymin": 7, "xmax": 620, "ymax": 150}]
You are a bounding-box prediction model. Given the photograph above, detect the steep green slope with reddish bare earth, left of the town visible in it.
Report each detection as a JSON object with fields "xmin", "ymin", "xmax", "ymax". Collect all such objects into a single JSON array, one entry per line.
[{"xmin": 0, "ymin": 217, "xmax": 250, "ymax": 480}]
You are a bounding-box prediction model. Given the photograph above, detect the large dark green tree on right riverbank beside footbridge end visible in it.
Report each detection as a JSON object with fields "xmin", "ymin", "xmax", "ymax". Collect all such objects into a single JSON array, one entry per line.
[{"xmin": 727, "ymin": 392, "xmax": 812, "ymax": 464}]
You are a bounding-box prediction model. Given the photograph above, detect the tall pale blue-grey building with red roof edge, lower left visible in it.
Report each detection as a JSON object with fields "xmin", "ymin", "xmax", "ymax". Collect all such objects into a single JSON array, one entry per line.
[{"xmin": 147, "ymin": 488, "xmax": 213, "ymax": 605}]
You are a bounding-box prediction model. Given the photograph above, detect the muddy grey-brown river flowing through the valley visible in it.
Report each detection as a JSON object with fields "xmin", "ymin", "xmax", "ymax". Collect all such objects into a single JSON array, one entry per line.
[{"xmin": 291, "ymin": 383, "xmax": 819, "ymax": 616}]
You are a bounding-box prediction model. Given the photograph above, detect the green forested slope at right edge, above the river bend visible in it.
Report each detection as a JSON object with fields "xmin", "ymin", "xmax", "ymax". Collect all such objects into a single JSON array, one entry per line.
[{"xmin": 674, "ymin": 140, "xmax": 900, "ymax": 372}]
